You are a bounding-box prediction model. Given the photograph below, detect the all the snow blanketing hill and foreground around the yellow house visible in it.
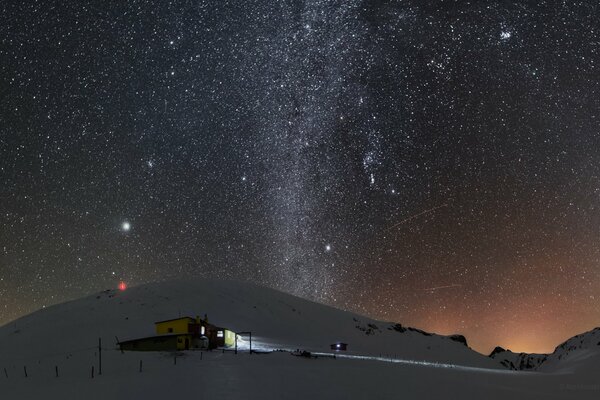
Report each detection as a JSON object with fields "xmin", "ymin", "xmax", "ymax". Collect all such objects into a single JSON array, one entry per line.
[{"xmin": 0, "ymin": 281, "xmax": 600, "ymax": 400}]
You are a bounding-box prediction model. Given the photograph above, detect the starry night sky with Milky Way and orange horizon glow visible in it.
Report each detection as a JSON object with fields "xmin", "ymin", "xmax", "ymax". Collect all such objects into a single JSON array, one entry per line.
[{"xmin": 0, "ymin": 0, "xmax": 600, "ymax": 352}]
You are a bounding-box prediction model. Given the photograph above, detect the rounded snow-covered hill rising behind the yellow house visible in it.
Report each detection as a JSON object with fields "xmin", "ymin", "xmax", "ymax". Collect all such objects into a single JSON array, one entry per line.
[{"xmin": 0, "ymin": 280, "xmax": 501, "ymax": 368}]
